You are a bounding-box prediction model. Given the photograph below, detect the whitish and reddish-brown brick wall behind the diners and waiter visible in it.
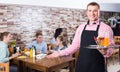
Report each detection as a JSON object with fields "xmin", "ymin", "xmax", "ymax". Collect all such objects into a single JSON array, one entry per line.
[{"xmin": 0, "ymin": 5, "xmax": 117, "ymax": 44}]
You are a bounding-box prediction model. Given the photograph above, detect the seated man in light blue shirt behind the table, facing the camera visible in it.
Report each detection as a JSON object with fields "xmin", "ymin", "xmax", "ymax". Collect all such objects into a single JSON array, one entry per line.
[{"xmin": 26, "ymin": 32, "xmax": 47, "ymax": 53}]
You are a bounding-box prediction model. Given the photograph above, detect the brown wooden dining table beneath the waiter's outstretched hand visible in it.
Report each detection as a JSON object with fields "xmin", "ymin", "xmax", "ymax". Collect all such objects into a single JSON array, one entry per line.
[{"xmin": 14, "ymin": 56, "xmax": 75, "ymax": 72}]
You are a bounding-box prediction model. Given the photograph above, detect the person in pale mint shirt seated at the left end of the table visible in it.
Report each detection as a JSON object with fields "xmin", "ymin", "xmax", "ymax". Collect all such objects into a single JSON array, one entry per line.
[{"xmin": 0, "ymin": 32, "xmax": 19, "ymax": 72}]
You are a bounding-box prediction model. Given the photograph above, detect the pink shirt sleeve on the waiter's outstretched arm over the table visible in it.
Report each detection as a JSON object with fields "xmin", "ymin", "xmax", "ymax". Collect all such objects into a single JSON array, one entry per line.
[{"xmin": 59, "ymin": 25, "xmax": 85, "ymax": 56}]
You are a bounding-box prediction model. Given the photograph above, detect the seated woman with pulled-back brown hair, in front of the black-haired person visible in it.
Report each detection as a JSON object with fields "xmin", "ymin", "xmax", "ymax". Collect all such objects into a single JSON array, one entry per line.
[{"xmin": 53, "ymin": 35, "xmax": 67, "ymax": 51}]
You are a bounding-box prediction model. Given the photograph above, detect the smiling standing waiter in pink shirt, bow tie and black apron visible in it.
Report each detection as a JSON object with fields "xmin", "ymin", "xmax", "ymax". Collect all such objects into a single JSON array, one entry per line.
[{"xmin": 47, "ymin": 2, "xmax": 114, "ymax": 72}]
